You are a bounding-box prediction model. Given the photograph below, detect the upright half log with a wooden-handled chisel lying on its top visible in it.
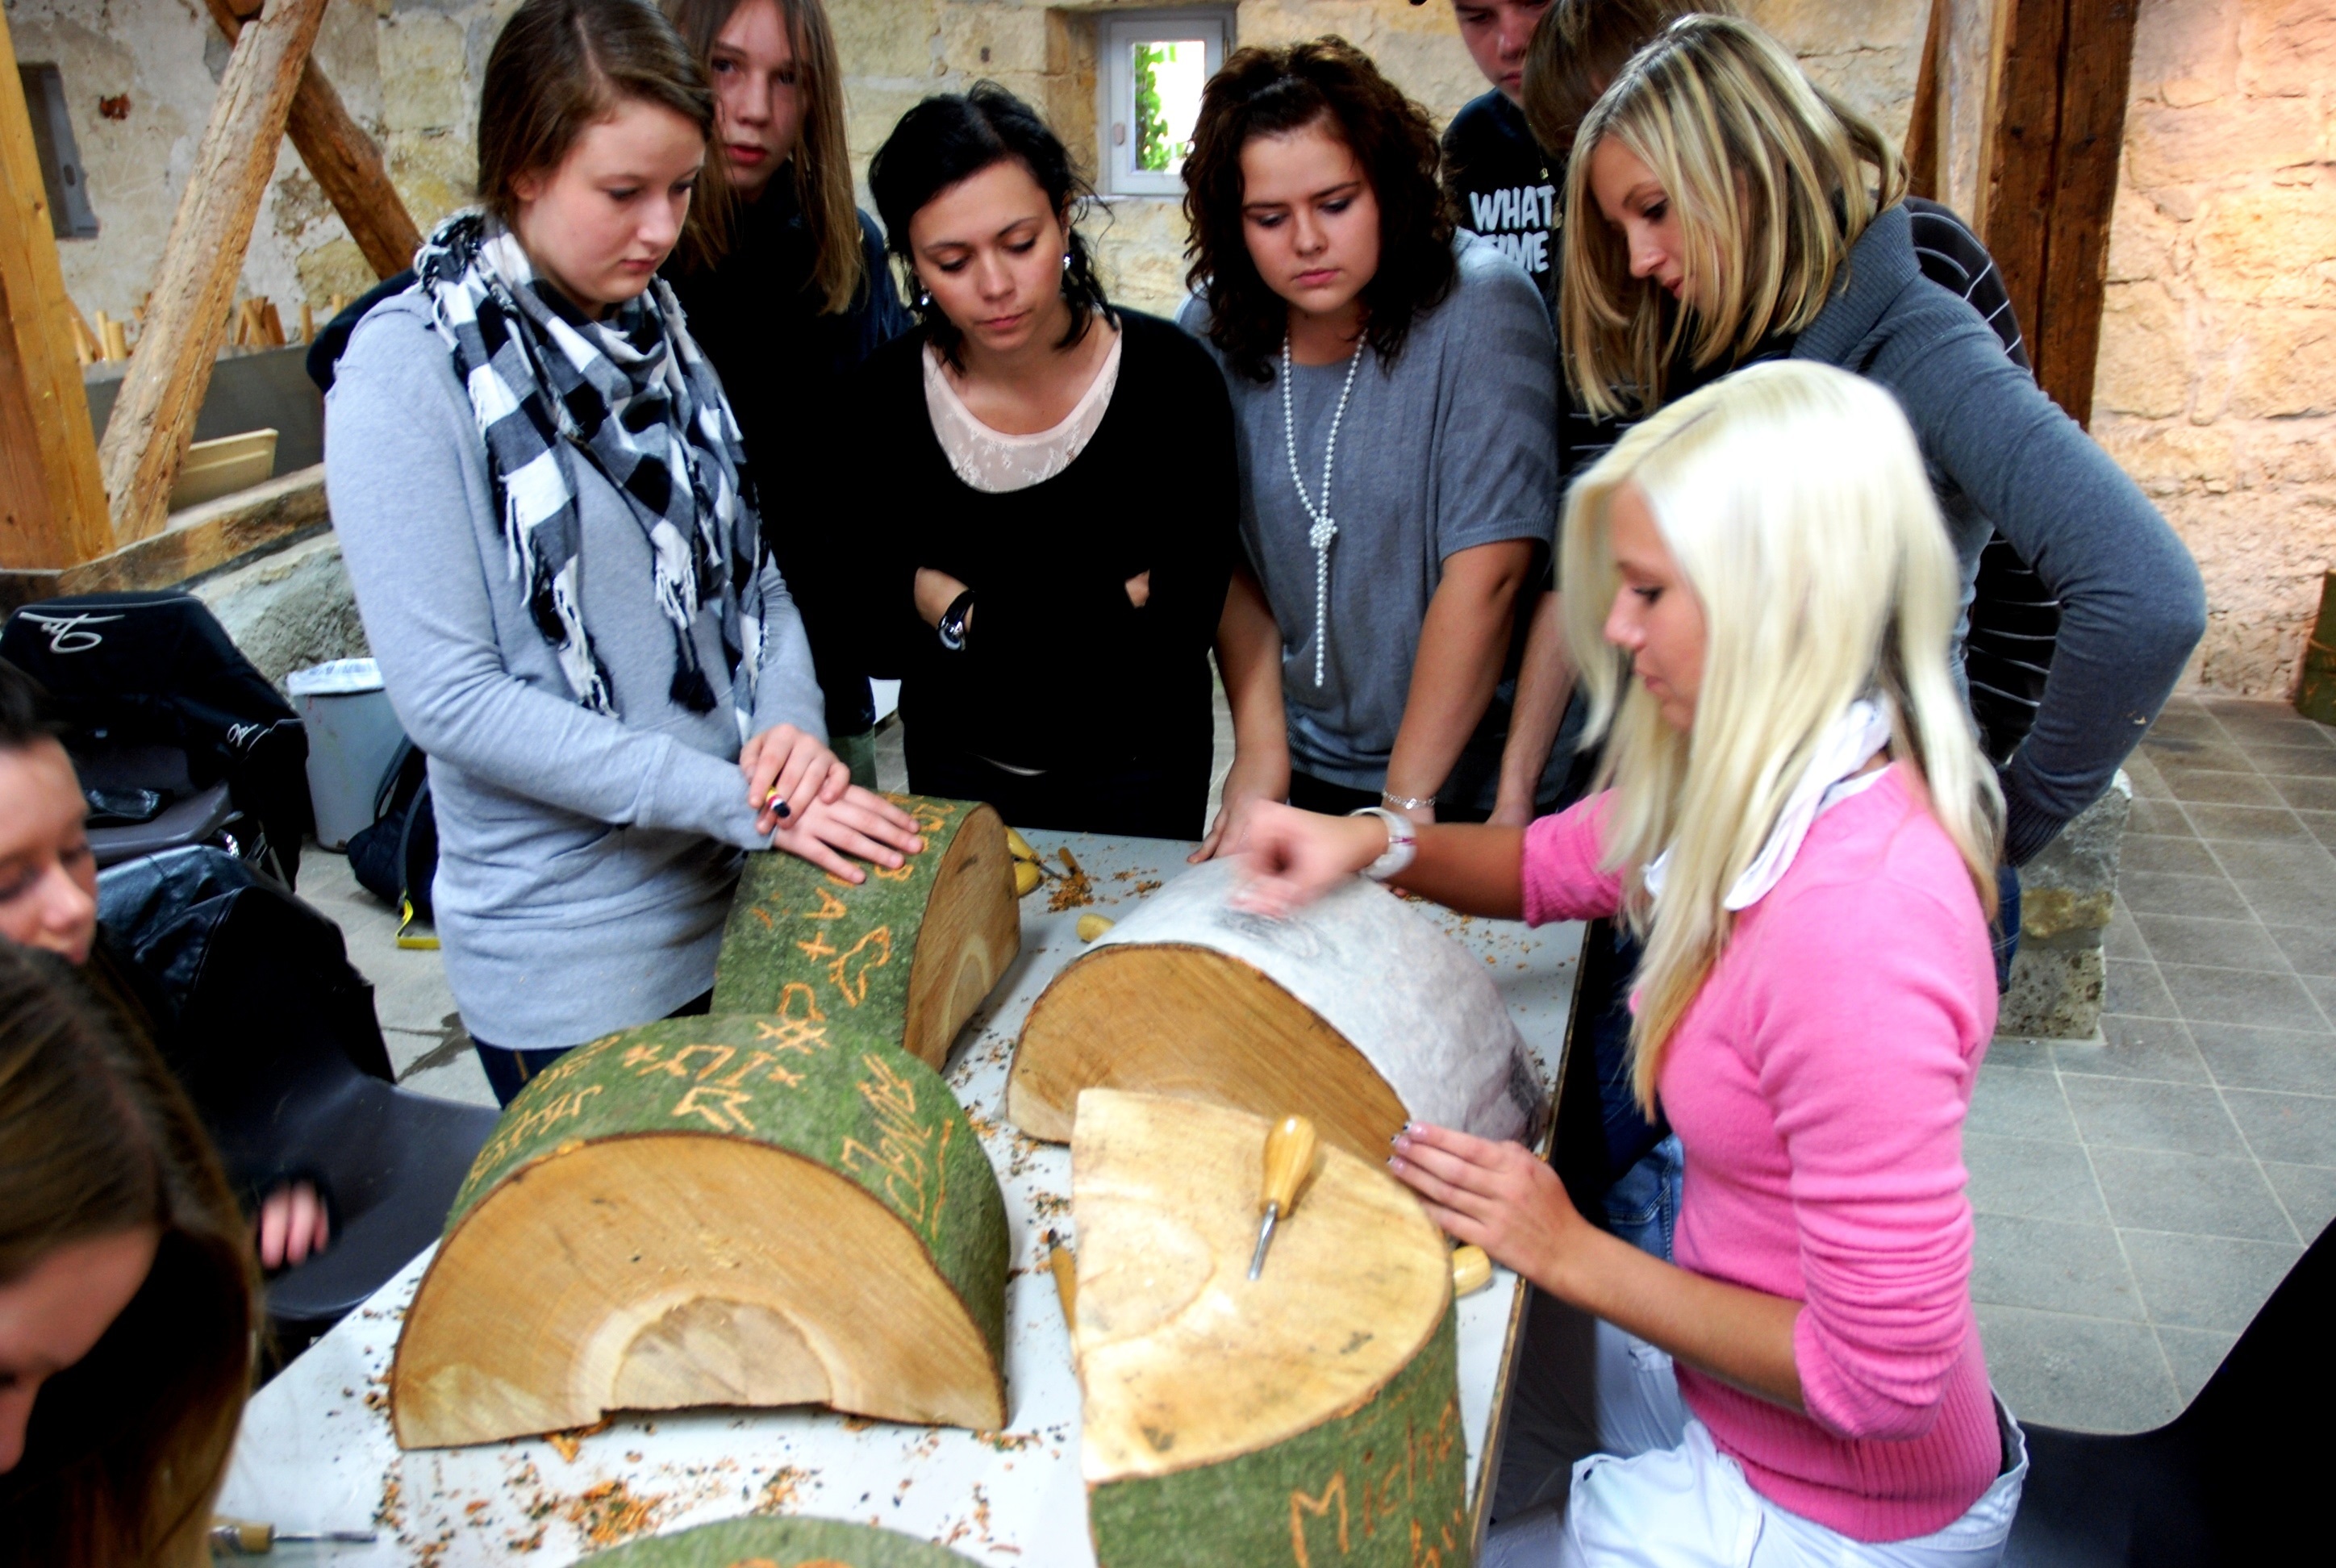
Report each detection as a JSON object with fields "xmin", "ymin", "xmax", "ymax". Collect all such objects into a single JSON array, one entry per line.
[{"xmin": 1070, "ymin": 1089, "xmax": 1471, "ymax": 1568}]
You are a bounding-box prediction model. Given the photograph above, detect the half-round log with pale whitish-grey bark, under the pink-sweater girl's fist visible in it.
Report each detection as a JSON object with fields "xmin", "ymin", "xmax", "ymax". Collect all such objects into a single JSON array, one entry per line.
[{"xmin": 1007, "ymin": 860, "xmax": 1549, "ymax": 1159}]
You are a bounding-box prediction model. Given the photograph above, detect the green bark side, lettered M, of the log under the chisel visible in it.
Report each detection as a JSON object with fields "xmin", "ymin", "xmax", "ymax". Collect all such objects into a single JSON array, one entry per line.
[{"xmin": 1087, "ymin": 1308, "xmax": 1474, "ymax": 1568}]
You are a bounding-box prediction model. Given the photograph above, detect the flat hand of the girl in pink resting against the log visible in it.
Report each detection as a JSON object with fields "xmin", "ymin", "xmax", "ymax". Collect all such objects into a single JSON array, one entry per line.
[{"xmin": 1387, "ymin": 1122, "xmax": 1591, "ymax": 1295}]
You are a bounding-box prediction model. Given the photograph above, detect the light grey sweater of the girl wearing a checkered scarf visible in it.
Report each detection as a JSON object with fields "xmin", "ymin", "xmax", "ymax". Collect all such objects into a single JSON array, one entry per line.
[{"xmin": 325, "ymin": 292, "xmax": 824, "ymax": 1049}]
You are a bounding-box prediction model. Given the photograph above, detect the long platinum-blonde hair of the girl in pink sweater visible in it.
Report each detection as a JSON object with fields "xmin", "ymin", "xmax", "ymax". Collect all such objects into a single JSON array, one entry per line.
[{"xmin": 1562, "ymin": 360, "xmax": 2002, "ymax": 1107}]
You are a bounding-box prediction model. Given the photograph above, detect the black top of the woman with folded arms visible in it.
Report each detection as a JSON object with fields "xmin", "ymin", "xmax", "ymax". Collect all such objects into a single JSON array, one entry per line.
[{"xmin": 834, "ymin": 311, "xmax": 1241, "ymax": 771}]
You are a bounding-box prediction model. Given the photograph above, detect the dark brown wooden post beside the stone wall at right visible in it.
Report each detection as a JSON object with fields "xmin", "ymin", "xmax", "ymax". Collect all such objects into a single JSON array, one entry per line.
[{"xmin": 2028, "ymin": 0, "xmax": 2140, "ymax": 425}]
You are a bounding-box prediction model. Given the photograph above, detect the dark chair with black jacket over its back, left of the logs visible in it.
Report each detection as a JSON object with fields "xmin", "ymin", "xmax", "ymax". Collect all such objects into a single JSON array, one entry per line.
[{"xmin": 101, "ymin": 849, "xmax": 498, "ymax": 1353}]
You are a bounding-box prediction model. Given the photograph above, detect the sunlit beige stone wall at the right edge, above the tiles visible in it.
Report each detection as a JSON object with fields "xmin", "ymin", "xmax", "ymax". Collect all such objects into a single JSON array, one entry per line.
[{"xmin": 2093, "ymin": 0, "xmax": 2336, "ymax": 696}]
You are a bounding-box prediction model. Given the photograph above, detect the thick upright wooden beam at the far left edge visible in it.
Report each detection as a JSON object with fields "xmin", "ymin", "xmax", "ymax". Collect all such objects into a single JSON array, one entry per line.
[{"xmin": 0, "ymin": 14, "xmax": 112, "ymax": 568}]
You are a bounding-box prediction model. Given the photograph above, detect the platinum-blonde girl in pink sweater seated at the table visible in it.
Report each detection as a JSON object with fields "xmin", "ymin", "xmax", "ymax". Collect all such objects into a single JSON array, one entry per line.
[{"xmin": 1241, "ymin": 362, "xmax": 2025, "ymax": 1568}]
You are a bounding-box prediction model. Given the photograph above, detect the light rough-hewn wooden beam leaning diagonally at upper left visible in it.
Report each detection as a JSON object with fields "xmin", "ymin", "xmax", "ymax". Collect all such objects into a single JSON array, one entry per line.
[{"xmin": 98, "ymin": 0, "xmax": 325, "ymax": 544}]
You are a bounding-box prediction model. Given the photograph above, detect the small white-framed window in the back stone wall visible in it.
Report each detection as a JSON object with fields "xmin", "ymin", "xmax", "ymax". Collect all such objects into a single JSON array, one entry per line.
[{"xmin": 1095, "ymin": 10, "xmax": 1233, "ymax": 196}]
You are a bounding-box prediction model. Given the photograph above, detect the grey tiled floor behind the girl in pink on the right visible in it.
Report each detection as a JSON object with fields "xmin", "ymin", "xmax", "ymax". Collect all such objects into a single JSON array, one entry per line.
[{"xmin": 1965, "ymin": 699, "xmax": 2336, "ymax": 1430}]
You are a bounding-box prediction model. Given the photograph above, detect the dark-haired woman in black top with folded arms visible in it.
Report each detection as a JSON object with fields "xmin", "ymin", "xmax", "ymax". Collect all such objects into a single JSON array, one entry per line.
[{"xmin": 850, "ymin": 81, "xmax": 1238, "ymax": 839}]
